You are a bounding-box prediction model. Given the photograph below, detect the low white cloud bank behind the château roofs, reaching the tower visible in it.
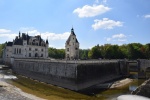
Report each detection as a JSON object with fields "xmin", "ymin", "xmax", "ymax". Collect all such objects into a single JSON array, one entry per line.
[{"xmin": 0, "ymin": 28, "xmax": 70, "ymax": 48}]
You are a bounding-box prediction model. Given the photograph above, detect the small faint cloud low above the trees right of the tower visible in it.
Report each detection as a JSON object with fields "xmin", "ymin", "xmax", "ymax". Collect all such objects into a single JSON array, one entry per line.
[{"xmin": 105, "ymin": 33, "xmax": 127, "ymax": 42}]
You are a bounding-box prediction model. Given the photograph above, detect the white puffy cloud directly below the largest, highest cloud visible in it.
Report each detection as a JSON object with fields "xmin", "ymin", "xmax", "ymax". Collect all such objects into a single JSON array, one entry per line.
[{"xmin": 92, "ymin": 18, "xmax": 123, "ymax": 30}]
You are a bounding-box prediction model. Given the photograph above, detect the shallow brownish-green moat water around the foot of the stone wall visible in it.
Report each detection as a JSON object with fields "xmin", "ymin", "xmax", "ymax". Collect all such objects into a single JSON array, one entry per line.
[{"xmin": 0, "ymin": 70, "xmax": 144, "ymax": 100}]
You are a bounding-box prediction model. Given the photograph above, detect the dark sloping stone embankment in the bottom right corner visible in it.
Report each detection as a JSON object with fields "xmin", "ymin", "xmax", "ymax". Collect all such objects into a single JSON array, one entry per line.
[{"xmin": 132, "ymin": 79, "xmax": 150, "ymax": 98}]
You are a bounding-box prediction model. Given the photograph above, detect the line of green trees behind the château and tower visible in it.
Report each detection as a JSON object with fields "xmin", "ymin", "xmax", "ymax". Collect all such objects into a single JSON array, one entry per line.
[{"xmin": 0, "ymin": 43, "xmax": 150, "ymax": 60}]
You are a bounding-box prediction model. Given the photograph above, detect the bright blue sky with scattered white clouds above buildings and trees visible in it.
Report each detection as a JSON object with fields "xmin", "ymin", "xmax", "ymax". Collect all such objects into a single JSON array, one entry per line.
[{"xmin": 0, "ymin": 0, "xmax": 150, "ymax": 49}]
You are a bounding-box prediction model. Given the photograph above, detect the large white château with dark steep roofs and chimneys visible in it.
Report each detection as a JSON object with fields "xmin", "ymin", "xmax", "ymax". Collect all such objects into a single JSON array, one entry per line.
[{"xmin": 3, "ymin": 32, "xmax": 49, "ymax": 63}]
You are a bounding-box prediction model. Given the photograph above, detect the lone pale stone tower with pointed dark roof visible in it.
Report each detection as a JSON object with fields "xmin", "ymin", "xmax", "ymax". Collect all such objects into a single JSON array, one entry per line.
[{"xmin": 65, "ymin": 28, "xmax": 79, "ymax": 60}]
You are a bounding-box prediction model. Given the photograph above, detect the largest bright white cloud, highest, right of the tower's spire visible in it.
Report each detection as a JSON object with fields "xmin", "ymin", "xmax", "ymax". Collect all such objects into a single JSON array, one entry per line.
[{"xmin": 73, "ymin": 5, "xmax": 111, "ymax": 18}]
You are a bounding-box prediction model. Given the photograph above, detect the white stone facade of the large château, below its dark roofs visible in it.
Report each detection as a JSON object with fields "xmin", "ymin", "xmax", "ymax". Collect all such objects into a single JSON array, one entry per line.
[{"xmin": 3, "ymin": 35, "xmax": 48, "ymax": 63}]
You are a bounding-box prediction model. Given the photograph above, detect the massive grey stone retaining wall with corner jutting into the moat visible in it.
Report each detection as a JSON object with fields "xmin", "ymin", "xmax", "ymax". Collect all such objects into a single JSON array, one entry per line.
[{"xmin": 12, "ymin": 59, "xmax": 123, "ymax": 91}]
